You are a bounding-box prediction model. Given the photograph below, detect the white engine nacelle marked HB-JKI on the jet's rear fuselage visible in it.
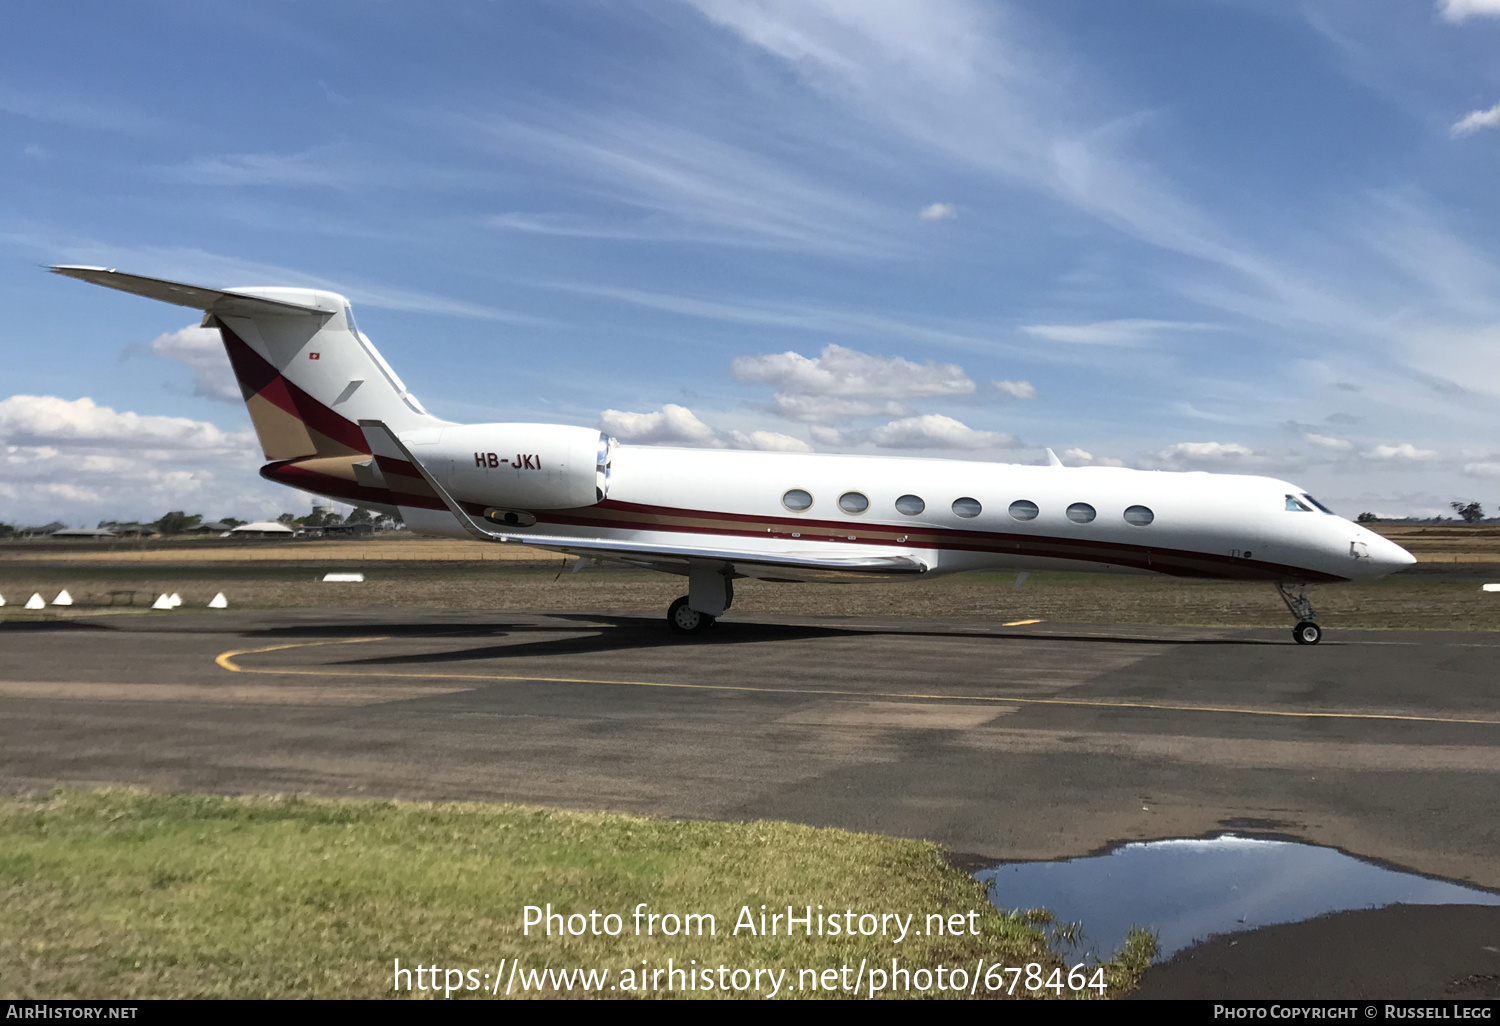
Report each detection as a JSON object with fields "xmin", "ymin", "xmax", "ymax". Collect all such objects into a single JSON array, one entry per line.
[{"xmin": 402, "ymin": 425, "xmax": 615, "ymax": 510}]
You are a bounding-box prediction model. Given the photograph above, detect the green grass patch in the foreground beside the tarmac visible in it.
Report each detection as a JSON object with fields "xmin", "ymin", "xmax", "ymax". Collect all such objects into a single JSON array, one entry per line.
[{"xmin": 0, "ymin": 789, "xmax": 1155, "ymax": 999}]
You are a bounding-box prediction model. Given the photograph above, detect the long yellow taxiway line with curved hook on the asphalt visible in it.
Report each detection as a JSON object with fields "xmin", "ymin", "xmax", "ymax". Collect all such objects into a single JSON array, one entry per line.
[{"xmin": 213, "ymin": 635, "xmax": 1500, "ymax": 726}]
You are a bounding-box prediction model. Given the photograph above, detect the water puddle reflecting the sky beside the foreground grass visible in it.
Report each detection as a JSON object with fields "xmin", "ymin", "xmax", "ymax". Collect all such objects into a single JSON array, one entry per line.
[{"xmin": 975, "ymin": 834, "xmax": 1500, "ymax": 960}]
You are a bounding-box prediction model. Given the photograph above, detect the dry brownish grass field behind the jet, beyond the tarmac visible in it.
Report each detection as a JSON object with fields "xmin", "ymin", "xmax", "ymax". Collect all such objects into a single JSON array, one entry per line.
[{"xmin": 0, "ymin": 525, "xmax": 1500, "ymax": 630}]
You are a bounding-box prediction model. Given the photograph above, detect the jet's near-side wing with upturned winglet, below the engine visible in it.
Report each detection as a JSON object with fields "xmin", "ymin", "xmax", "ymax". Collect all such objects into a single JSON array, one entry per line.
[{"xmin": 360, "ymin": 420, "xmax": 927, "ymax": 581}]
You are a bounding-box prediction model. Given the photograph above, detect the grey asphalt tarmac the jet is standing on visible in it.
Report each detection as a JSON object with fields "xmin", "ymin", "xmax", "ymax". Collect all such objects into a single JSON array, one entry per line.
[{"xmin": 0, "ymin": 611, "xmax": 1500, "ymax": 998}]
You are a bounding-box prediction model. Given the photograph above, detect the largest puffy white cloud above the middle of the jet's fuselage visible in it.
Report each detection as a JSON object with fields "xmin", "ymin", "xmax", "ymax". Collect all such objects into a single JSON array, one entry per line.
[{"xmin": 732, "ymin": 345, "xmax": 975, "ymax": 399}]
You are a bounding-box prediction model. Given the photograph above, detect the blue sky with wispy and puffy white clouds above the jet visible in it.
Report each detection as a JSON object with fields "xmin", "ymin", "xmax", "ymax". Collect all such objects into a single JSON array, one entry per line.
[{"xmin": 0, "ymin": 0, "xmax": 1500, "ymax": 524}]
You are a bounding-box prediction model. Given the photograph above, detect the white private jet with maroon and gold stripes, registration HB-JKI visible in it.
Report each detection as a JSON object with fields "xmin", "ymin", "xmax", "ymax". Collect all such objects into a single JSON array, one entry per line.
[{"xmin": 53, "ymin": 267, "xmax": 1415, "ymax": 645}]
